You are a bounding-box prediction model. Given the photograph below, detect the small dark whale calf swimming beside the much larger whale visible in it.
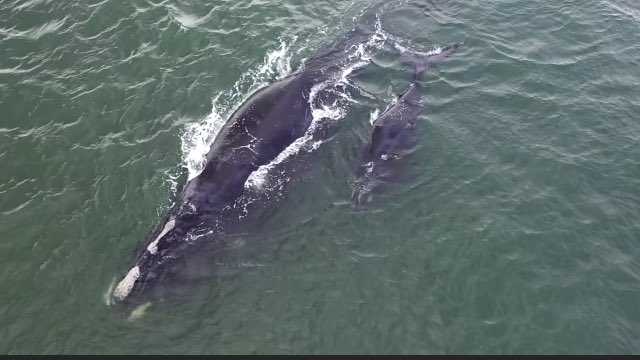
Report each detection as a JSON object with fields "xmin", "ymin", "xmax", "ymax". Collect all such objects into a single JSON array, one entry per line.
[{"xmin": 352, "ymin": 44, "xmax": 461, "ymax": 206}]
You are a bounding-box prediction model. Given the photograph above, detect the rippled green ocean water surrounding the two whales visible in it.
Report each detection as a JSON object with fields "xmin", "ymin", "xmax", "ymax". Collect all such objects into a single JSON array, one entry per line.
[{"xmin": 0, "ymin": 0, "xmax": 640, "ymax": 354}]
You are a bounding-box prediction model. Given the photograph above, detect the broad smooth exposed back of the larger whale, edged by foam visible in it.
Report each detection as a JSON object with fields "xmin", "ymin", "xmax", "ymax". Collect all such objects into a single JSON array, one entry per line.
[{"xmin": 184, "ymin": 74, "xmax": 311, "ymax": 212}]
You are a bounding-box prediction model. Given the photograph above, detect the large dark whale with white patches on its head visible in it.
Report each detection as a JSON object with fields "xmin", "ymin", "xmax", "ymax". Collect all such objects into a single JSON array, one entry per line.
[{"xmin": 112, "ymin": 25, "xmax": 382, "ymax": 301}]
